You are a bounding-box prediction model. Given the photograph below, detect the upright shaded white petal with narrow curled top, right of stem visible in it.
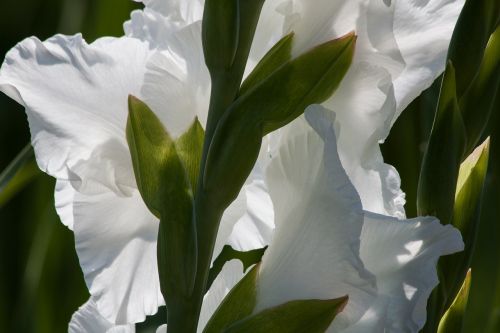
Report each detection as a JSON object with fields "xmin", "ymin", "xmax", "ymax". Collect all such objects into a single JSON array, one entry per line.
[{"xmin": 255, "ymin": 109, "xmax": 375, "ymax": 329}]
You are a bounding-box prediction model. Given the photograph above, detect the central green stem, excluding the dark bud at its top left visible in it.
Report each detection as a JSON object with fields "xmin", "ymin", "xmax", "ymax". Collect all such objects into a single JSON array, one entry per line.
[{"xmin": 167, "ymin": 0, "xmax": 264, "ymax": 333}]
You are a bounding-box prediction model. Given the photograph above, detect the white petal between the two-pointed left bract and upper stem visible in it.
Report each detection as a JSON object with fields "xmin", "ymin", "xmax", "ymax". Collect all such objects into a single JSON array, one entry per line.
[{"xmin": 141, "ymin": 22, "xmax": 211, "ymax": 136}]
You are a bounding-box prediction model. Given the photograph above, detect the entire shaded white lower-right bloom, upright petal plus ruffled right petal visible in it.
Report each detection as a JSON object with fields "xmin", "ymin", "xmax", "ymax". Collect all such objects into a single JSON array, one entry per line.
[{"xmin": 256, "ymin": 106, "xmax": 463, "ymax": 333}]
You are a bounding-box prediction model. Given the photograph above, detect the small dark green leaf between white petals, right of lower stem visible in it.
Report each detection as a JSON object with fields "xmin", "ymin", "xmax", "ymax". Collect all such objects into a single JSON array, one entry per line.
[{"xmin": 206, "ymin": 245, "xmax": 267, "ymax": 291}]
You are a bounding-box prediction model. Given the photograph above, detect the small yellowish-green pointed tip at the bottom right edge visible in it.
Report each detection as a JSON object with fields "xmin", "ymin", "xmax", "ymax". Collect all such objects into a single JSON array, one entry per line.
[{"xmin": 438, "ymin": 270, "xmax": 471, "ymax": 333}]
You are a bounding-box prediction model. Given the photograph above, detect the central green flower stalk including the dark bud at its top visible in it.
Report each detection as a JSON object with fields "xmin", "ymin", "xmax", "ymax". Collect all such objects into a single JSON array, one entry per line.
[{"xmin": 167, "ymin": 0, "xmax": 264, "ymax": 333}]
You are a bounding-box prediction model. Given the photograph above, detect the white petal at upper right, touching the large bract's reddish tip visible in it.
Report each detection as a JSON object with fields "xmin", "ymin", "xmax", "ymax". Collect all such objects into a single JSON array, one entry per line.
[{"xmin": 254, "ymin": 0, "xmax": 405, "ymax": 218}]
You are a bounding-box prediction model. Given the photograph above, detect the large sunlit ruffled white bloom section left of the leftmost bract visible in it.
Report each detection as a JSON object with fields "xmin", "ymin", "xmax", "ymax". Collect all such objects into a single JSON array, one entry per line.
[{"xmin": 0, "ymin": 35, "xmax": 169, "ymax": 324}]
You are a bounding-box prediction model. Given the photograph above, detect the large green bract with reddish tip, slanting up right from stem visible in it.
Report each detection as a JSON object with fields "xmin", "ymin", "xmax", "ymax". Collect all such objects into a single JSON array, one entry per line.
[{"xmin": 203, "ymin": 34, "xmax": 356, "ymax": 206}]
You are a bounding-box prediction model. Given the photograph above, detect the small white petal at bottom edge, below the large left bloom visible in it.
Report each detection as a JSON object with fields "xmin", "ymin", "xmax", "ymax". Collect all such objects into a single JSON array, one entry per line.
[{"xmin": 68, "ymin": 298, "xmax": 135, "ymax": 333}]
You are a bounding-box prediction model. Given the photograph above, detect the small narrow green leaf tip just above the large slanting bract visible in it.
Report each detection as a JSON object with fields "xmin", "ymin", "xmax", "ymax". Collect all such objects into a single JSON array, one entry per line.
[{"xmin": 238, "ymin": 32, "xmax": 294, "ymax": 96}]
